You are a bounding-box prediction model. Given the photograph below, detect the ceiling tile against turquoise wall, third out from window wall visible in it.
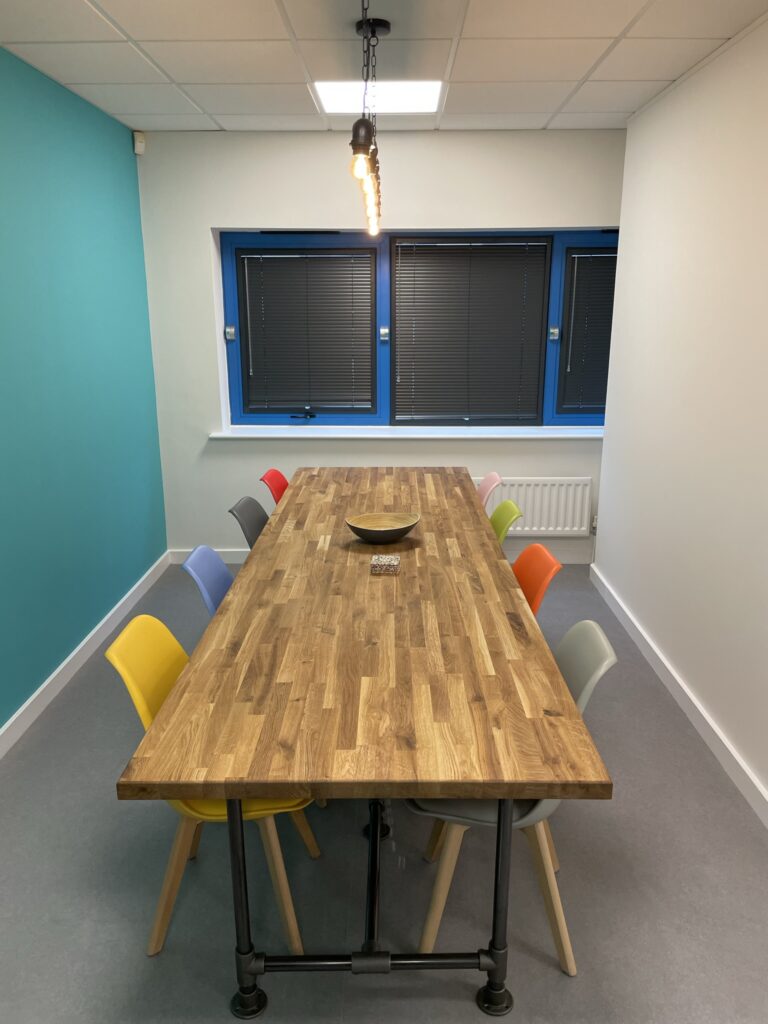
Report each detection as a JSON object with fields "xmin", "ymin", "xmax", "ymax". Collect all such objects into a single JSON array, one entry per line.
[{"xmin": 8, "ymin": 43, "xmax": 165, "ymax": 85}]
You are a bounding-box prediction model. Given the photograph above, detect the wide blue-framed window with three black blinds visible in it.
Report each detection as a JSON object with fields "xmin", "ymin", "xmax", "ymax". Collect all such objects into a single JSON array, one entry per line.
[{"xmin": 221, "ymin": 231, "xmax": 616, "ymax": 426}]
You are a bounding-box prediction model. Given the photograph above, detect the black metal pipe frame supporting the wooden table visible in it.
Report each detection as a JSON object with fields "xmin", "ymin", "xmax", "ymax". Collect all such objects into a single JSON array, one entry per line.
[{"xmin": 226, "ymin": 799, "xmax": 520, "ymax": 1020}]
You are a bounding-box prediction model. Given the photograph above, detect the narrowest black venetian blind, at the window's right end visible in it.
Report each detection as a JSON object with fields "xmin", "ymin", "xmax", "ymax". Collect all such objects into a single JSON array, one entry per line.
[{"xmin": 557, "ymin": 249, "xmax": 616, "ymax": 413}]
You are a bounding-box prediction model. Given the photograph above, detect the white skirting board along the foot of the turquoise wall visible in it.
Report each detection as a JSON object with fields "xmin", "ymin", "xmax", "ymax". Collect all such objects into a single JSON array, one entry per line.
[{"xmin": 0, "ymin": 551, "xmax": 170, "ymax": 758}]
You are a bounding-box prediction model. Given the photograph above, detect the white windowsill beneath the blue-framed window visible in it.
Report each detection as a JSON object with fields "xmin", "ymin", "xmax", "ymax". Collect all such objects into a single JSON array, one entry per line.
[{"xmin": 208, "ymin": 426, "xmax": 603, "ymax": 441}]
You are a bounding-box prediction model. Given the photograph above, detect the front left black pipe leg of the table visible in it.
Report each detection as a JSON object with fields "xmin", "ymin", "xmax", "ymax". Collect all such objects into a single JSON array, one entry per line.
[{"xmin": 226, "ymin": 800, "xmax": 266, "ymax": 1020}]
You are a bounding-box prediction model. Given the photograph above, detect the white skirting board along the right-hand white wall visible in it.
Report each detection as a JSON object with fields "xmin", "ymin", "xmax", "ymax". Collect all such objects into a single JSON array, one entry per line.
[{"xmin": 590, "ymin": 563, "xmax": 768, "ymax": 828}]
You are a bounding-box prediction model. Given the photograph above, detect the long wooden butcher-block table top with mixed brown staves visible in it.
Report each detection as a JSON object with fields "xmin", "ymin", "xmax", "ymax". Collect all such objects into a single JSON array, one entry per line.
[{"xmin": 118, "ymin": 467, "xmax": 611, "ymax": 800}]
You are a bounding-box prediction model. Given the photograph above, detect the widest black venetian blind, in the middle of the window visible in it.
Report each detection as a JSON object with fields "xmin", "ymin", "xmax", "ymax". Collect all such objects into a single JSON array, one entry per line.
[{"xmin": 392, "ymin": 238, "xmax": 550, "ymax": 423}]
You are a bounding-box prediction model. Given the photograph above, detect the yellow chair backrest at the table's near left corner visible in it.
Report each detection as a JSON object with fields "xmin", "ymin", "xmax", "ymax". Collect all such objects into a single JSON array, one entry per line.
[{"xmin": 104, "ymin": 615, "xmax": 188, "ymax": 729}]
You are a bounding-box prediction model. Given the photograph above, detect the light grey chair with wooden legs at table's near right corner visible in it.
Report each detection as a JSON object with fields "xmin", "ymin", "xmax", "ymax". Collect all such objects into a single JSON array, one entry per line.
[{"xmin": 407, "ymin": 620, "xmax": 616, "ymax": 976}]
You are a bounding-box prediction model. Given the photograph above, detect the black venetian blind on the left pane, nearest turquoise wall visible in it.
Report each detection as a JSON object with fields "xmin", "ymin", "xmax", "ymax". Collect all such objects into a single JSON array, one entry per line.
[{"xmin": 237, "ymin": 249, "xmax": 376, "ymax": 412}]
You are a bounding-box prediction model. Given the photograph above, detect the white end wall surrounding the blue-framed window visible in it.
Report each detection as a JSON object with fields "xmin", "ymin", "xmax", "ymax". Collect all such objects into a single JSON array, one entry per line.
[{"xmin": 138, "ymin": 131, "xmax": 624, "ymax": 561}]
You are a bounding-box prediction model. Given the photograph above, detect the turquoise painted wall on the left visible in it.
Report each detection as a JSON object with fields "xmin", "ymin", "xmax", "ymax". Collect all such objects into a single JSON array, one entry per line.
[{"xmin": 0, "ymin": 49, "xmax": 166, "ymax": 724}]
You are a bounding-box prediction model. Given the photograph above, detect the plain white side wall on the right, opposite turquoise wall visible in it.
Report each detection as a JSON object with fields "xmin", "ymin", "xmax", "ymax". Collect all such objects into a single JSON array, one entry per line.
[{"xmin": 596, "ymin": 25, "xmax": 768, "ymax": 826}]
